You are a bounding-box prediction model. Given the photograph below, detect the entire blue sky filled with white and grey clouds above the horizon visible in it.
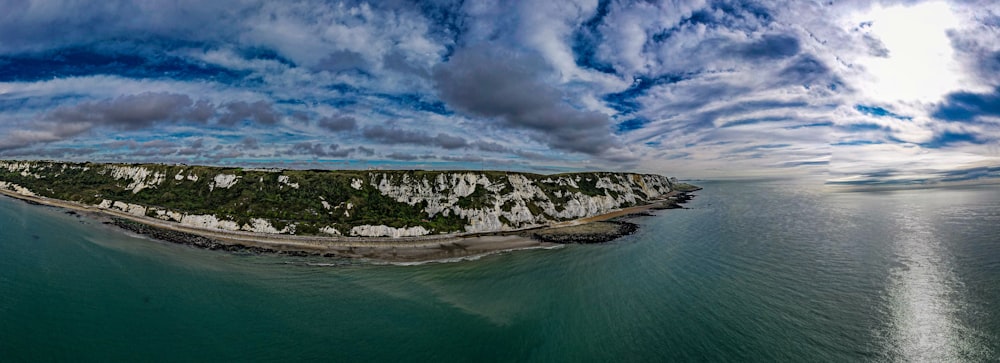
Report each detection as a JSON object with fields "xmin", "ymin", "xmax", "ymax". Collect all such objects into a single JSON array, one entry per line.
[{"xmin": 0, "ymin": 0, "xmax": 1000, "ymax": 185}]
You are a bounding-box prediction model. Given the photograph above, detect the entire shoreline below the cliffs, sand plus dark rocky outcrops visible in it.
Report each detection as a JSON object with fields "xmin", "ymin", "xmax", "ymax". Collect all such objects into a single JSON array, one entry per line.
[{"xmin": 0, "ymin": 188, "xmax": 700, "ymax": 264}]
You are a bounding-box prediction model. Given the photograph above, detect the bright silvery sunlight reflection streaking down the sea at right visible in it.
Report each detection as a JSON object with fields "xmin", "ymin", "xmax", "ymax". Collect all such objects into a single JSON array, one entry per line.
[{"xmin": 887, "ymin": 203, "xmax": 964, "ymax": 362}]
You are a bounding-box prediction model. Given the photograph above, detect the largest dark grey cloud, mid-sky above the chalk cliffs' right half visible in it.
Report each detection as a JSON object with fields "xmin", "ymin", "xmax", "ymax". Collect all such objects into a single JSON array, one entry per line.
[{"xmin": 434, "ymin": 47, "xmax": 617, "ymax": 155}]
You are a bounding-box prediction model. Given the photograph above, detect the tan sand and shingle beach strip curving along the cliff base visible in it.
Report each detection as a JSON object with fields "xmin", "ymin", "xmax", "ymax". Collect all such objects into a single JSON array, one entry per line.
[{"xmin": 0, "ymin": 190, "xmax": 696, "ymax": 262}]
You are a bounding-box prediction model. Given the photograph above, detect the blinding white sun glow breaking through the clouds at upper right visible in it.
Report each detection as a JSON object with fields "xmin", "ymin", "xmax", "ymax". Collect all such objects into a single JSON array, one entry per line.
[{"xmin": 851, "ymin": 2, "xmax": 963, "ymax": 102}]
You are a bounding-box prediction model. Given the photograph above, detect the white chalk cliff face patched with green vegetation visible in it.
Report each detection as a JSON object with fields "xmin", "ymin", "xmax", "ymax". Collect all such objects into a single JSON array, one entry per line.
[{"xmin": 0, "ymin": 161, "xmax": 673, "ymax": 237}]
